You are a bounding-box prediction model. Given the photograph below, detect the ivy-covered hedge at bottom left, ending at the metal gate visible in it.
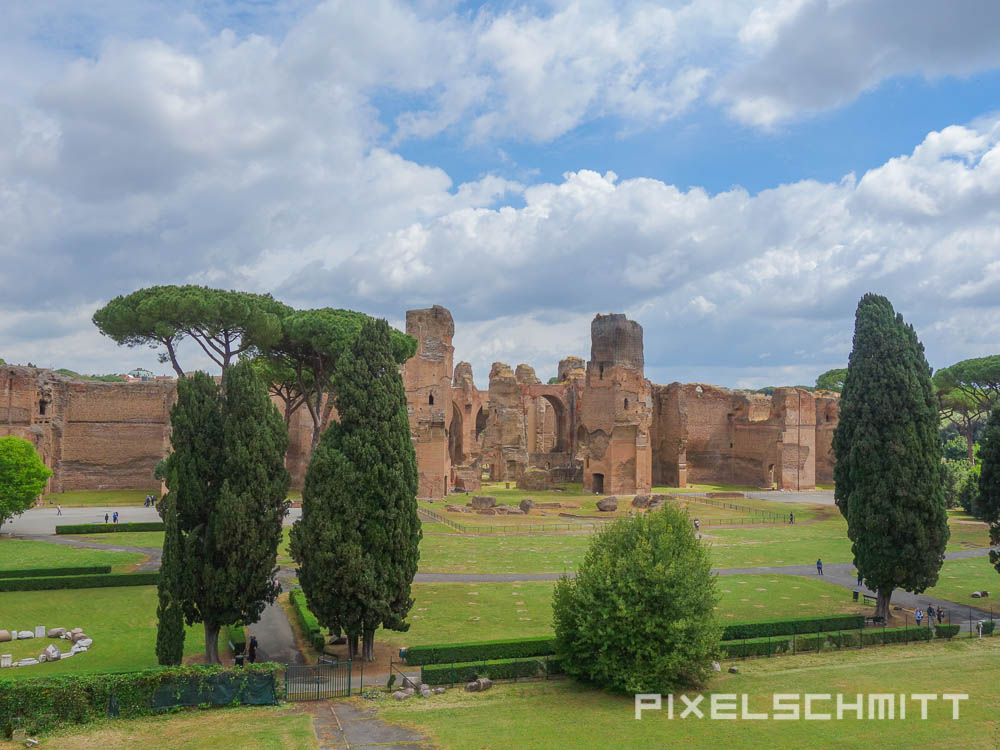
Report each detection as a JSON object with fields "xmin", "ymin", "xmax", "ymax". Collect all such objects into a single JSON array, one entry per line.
[{"xmin": 0, "ymin": 663, "xmax": 281, "ymax": 737}]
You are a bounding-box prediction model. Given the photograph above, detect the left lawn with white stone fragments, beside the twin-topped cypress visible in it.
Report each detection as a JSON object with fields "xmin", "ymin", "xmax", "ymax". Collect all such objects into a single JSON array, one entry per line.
[{"xmin": 0, "ymin": 586, "xmax": 219, "ymax": 679}]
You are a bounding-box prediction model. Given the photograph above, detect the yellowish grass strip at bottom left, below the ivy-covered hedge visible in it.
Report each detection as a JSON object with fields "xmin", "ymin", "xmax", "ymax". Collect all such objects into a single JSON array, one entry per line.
[{"xmin": 0, "ymin": 712, "xmax": 319, "ymax": 750}]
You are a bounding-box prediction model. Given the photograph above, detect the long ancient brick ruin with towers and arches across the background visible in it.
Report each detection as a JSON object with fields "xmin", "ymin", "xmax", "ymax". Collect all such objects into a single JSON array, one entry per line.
[{"xmin": 0, "ymin": 306, "xmax": 838, "ymax": 498}]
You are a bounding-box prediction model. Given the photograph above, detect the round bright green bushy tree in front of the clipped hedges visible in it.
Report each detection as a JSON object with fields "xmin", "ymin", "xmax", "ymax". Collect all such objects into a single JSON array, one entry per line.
[{"xmin": 552, "ymin": 505, "xmax": 721, "ymax": 693}]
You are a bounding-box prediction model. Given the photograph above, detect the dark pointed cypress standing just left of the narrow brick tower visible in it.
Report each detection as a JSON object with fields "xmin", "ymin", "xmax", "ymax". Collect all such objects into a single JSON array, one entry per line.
[{"xmin": 291, "ymin": 319, "xmax": 421, "ymax": 661}]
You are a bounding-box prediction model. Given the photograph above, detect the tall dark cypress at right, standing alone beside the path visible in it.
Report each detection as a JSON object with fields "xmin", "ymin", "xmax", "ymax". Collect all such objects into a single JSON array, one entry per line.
[{"xmin": 833, "ymin": 294, "xmax": 949, "ymax": 620}]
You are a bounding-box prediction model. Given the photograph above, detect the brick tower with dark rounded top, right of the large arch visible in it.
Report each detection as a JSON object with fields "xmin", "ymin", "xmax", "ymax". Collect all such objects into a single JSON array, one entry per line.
[{"xmin": 577, "ymin": 313, "xmax": 653, "ymax": 494}]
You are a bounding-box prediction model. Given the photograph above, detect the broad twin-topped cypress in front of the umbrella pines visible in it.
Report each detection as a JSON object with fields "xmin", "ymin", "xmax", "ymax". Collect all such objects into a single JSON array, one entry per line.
[{"xmin": 158, "ymin": 361, "xmax": 290, "ymax": 662}]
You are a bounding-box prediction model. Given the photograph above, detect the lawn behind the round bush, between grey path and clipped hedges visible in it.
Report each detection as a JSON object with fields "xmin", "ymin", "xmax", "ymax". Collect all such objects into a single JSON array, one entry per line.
[{"xmin": 378, "ymin": 575, "xmax": 859, "ymax": 646}]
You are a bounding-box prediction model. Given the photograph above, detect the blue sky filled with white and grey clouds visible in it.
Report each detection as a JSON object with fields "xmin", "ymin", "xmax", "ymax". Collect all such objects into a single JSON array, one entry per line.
[{"xmin": 0, "ymin": 0, "xmax": 1000, "ymax": 387}]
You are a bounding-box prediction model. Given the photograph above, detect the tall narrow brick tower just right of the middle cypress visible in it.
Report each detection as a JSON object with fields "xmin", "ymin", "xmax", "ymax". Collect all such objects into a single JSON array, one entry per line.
[{"xmin": 403, "ymin": 305, "xmax": 455, "ymax": 497}]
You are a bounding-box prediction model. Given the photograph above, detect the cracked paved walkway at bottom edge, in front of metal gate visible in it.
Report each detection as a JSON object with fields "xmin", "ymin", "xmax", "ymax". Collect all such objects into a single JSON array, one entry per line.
[{"xmin": 309, "ymin": 701, "xmax": 433, "ymax": 750}]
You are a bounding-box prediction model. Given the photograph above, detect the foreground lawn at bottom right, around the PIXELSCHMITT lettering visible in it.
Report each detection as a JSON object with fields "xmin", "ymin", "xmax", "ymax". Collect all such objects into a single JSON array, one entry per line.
[{"xmin": 379, "ymin": 638, "xmax": 1000, "ymax": 750}]
